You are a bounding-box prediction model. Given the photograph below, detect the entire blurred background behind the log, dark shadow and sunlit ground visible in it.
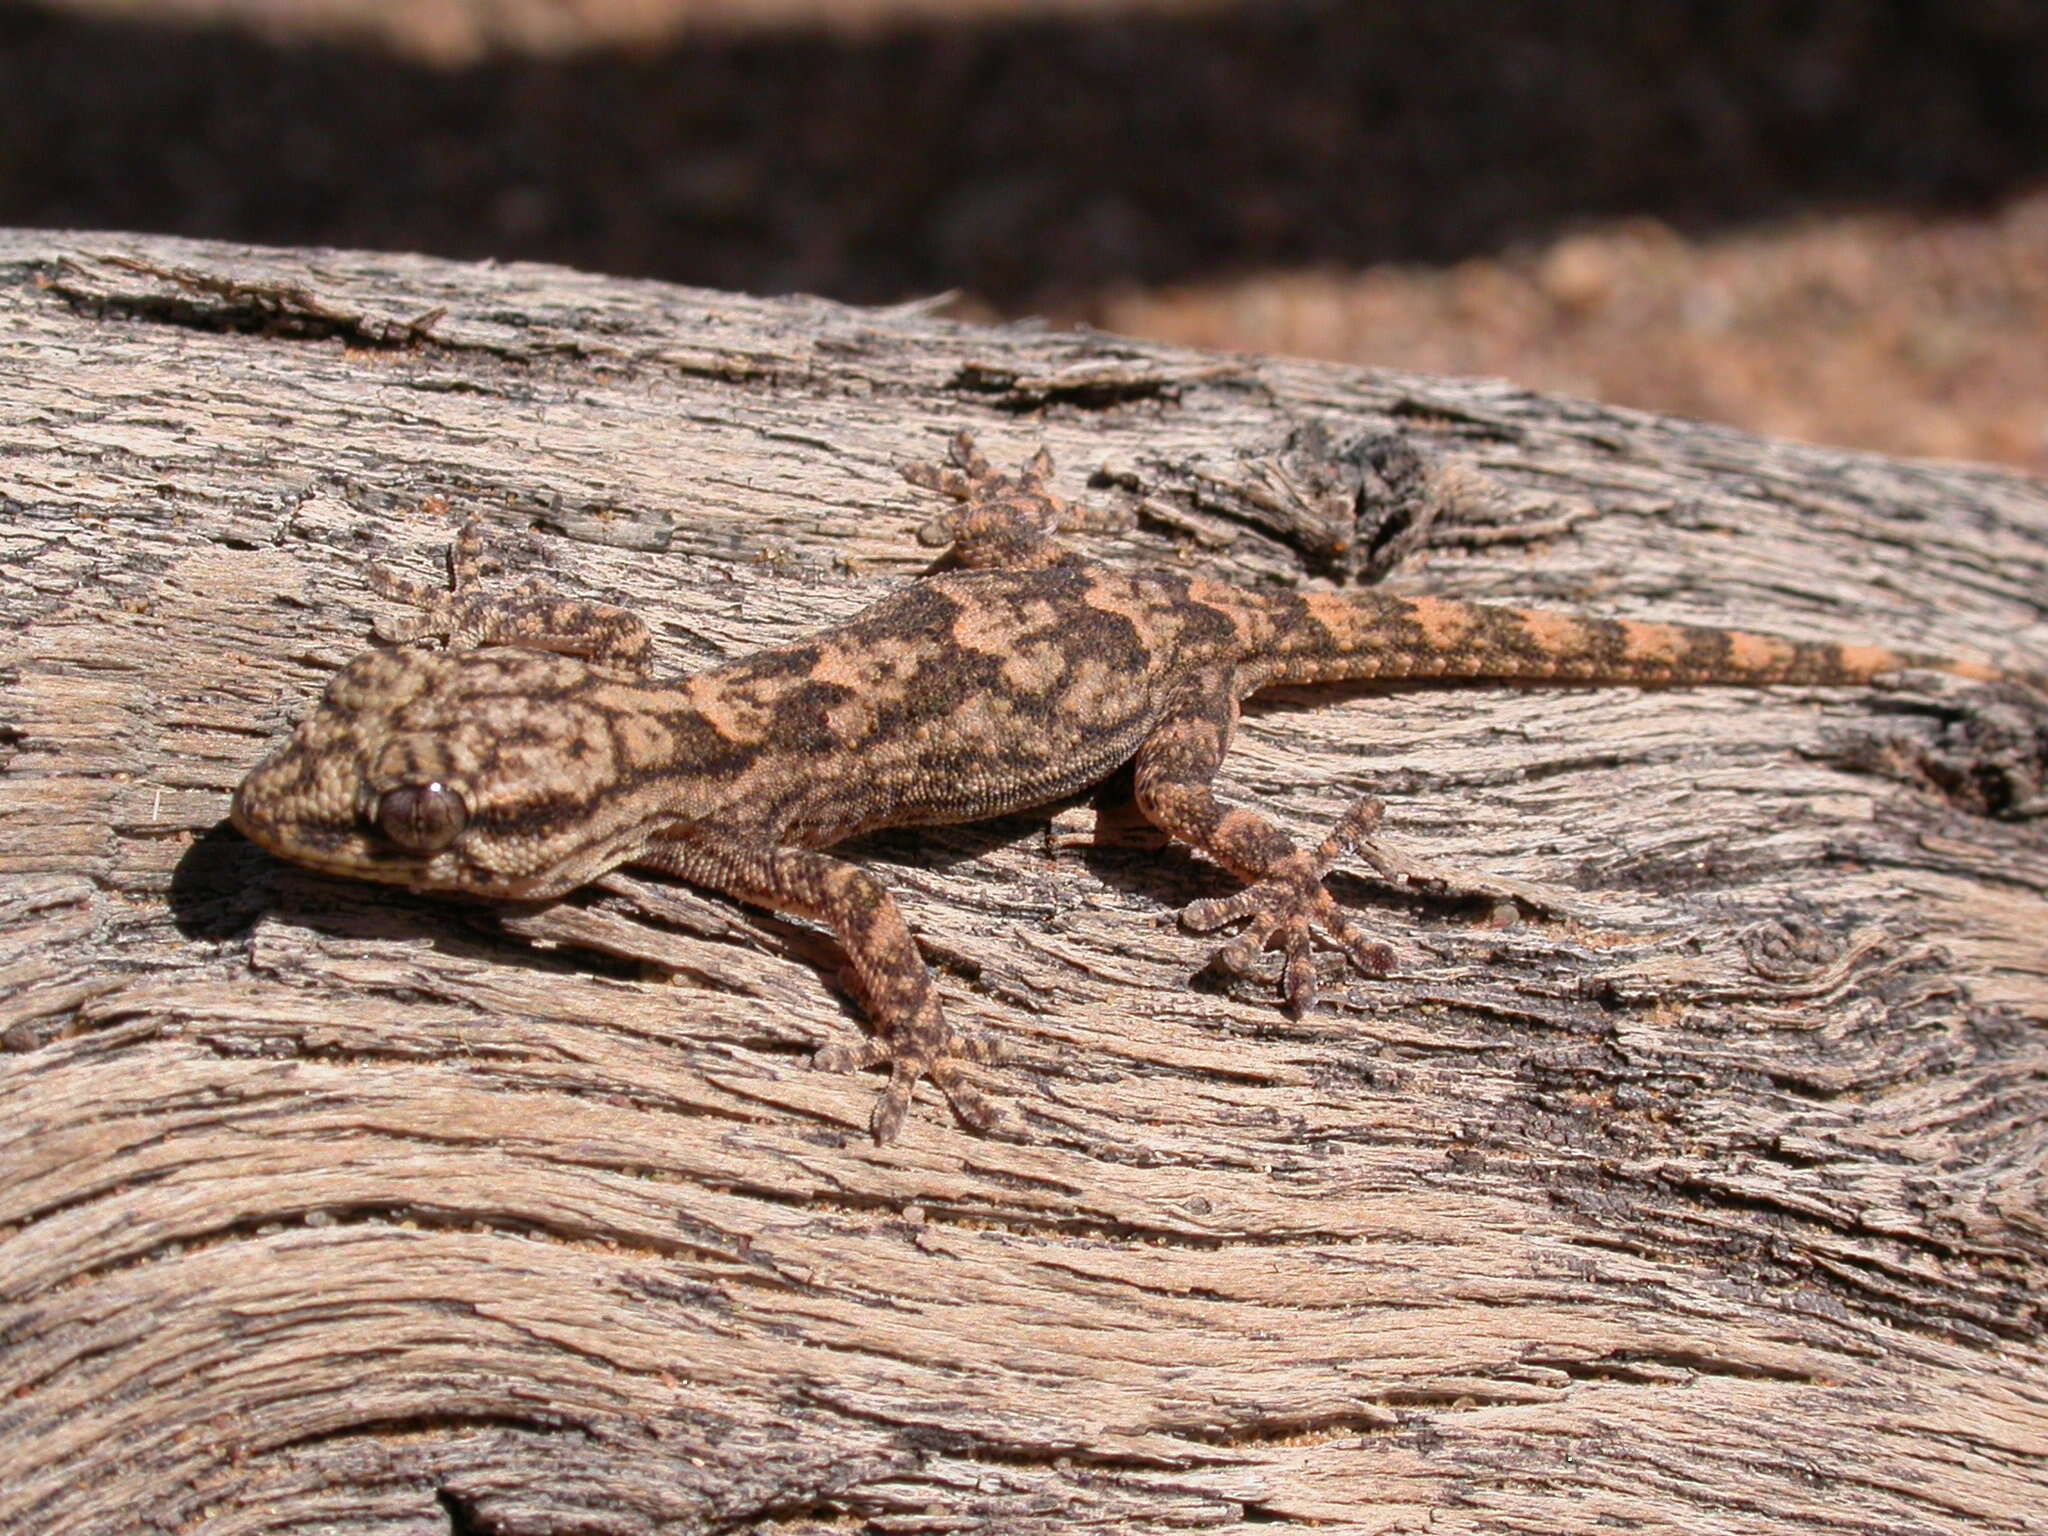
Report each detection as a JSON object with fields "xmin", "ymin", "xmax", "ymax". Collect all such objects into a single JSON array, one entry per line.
[{"xmin": 0, "ymin": 0, "xmax": 2048, "ymax": 473}]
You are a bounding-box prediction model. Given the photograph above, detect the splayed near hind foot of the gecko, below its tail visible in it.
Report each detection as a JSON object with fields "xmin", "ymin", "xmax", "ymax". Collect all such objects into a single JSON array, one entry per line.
[{"xmin": 1180, "ymin": 799, "xmax": 1395, "ymax": 1014}]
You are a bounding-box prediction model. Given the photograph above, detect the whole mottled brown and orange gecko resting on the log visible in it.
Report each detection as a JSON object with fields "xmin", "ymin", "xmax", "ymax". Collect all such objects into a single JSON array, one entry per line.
[{"xmin": 231, "ymin": 432, "xmax": 2011, "ymax": 1143}]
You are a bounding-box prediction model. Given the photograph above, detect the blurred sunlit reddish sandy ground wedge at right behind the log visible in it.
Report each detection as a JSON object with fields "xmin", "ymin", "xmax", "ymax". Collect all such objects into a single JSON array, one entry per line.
[{"xmin": 1092, "ymin": 193, "xmax": 2048, "ymax": 473}]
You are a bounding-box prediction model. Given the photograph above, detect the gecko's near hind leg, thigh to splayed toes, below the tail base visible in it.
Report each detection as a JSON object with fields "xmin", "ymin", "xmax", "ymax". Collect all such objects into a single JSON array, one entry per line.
[{"xmin": 1135, "ymin": 668, "xmax": 1393, "ymax": 1014}]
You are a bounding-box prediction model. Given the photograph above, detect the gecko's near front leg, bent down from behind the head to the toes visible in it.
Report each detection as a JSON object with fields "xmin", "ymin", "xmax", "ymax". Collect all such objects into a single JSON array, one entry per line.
[{"xmin": 633, "ymin": 823, "xmax": 1004, "ymax": 1143}]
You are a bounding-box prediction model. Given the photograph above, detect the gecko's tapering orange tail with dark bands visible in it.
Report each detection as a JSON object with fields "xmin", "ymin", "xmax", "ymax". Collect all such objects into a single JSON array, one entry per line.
[{"xmin": 1266, "ymin": 594, "xmax": 2028, "ymax": 686}]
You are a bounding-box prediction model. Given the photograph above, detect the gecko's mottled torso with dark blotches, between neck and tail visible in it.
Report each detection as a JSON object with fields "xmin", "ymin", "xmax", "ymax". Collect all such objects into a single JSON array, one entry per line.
[{"xmin": 688, "ymin": 563, "xmax": 1239, "ymax": 848}]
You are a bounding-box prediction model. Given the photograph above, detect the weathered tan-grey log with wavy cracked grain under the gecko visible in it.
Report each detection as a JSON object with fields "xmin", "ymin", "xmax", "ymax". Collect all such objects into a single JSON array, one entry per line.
[{"xmin": 0, "ymin": 233, "xmax": 2048, "ymax": 1536}]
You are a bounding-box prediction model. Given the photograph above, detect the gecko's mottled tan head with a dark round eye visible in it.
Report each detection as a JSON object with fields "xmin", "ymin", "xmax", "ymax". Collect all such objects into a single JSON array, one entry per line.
[{"xmin": 229, "ymin": 647, "xmax": 679, "ymax": 899}]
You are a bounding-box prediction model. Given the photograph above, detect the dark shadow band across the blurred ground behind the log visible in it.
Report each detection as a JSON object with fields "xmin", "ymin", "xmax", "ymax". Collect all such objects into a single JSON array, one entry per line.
[{"xmin": 0, "ymin": 0, "xmax": 2048, "ymax": 311}]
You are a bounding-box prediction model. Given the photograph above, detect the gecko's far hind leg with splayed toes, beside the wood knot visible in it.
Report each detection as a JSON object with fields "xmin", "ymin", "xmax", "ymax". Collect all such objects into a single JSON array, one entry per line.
[{"xmin": 903, "ymin": 432, "xmax": 1130, "ymax": 571}]
